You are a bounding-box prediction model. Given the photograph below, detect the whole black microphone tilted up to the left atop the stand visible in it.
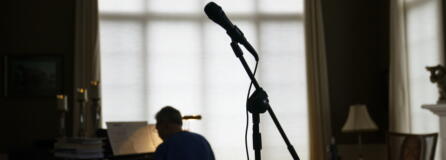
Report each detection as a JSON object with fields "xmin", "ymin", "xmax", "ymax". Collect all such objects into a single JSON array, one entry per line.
[{"xmin": 204, "ymin": 2, "xmax": 259, "ymax": 61}]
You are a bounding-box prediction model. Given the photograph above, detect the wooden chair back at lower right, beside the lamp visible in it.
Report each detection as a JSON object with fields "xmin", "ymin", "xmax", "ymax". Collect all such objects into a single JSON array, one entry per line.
[{"xmin": 387, "ymin": 132, "xmax": 438, "ymax": 160}]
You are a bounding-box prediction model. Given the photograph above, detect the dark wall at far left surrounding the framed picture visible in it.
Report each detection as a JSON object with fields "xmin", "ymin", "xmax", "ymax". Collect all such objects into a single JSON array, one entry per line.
[{"xmin": 0, "ymin": 0, "xmax": 75, "ymax": 153}]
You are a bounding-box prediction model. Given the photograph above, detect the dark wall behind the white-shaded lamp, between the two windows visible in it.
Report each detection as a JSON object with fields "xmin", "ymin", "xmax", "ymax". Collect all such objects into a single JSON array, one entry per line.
[{"xmin": 323, "ymin": 0, "xmax": 389, "ymax": 144}]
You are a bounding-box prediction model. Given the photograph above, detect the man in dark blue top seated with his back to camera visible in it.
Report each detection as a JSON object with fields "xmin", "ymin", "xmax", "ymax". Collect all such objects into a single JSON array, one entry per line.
[{"xmin": 155, "ymin": 106, "xmax": 215, "ymax": 160}]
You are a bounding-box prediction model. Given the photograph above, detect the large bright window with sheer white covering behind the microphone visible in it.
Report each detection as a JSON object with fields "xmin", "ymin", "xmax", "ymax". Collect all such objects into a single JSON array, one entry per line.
[{"xmin": 99, "ymin": 0, "xmax": 309, "ymax": 160}]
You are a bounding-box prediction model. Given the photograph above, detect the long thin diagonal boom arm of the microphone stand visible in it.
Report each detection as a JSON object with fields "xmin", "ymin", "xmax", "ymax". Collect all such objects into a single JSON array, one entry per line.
[{"xmin": 231, "ymin": 41, "xmax": 300, "ymax": 160}]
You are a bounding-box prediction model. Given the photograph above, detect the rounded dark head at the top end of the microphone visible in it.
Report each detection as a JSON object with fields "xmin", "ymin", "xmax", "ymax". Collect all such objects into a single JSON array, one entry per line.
[{"xmin": 204, "ymin": 2, "xmax": 234, "ymax": 30}]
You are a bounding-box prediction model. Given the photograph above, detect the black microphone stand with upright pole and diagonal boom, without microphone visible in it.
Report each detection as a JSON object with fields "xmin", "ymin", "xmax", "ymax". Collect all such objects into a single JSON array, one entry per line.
[{"xmin": 231, "ymin": 38, "xmax": 300, "ymax": 160}]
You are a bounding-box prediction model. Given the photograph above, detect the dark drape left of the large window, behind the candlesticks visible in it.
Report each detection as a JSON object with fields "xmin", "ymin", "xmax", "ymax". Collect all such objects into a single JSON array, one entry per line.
[{"xmin": 72, "ymin": 0, "xmax": 100, "ymax": 136}]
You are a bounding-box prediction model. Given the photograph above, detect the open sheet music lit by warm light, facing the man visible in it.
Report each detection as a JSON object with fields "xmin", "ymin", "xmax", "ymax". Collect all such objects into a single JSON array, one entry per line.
[{"xmin": 106, "ymin": 121, "xmax": 161, "ymax": 155}]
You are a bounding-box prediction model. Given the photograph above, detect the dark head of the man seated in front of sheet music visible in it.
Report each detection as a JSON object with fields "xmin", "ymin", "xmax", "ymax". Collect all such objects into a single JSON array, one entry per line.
[{"xmin": 155, "ymin": 106, "xmax": 183, "ymax": 140}]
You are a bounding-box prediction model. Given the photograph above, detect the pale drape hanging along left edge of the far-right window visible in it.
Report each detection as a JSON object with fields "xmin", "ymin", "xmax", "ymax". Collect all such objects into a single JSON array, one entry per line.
[{"xmin": 389, "ymin": 0, "xmax": 411, "ymax": 133}]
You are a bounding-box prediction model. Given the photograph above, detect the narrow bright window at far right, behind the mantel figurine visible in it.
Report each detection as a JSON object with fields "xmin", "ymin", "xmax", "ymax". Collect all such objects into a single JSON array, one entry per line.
[{"xmin": 405, "ymin": 0, "xmax": 444, "ymax": 159}]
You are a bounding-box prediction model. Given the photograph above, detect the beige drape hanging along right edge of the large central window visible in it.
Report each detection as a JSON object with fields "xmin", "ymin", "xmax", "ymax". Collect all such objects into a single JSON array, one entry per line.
[{"xmin": 305, "ymin": 0, "xmax": 331, "ymax": 160}]
